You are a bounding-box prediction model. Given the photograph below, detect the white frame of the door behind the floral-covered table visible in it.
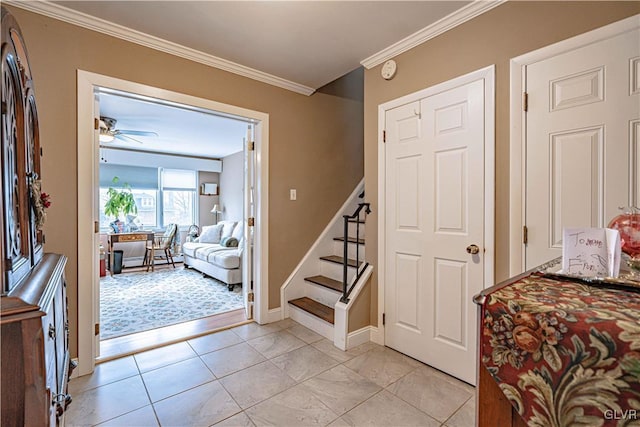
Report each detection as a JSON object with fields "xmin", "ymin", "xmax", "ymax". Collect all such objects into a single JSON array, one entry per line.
[{"xmin": 509, "ymin": 14, "xmax": 640, "ymax": 277}]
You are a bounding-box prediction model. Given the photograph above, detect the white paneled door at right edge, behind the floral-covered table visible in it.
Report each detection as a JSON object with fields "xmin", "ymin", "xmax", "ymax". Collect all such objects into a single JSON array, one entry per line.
[{"xmin": 525, "ymin": 29, "xmax": 640, "ymax": 269}]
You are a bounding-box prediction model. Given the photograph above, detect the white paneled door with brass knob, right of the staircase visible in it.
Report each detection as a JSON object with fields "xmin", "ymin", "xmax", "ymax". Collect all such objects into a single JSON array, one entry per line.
[{"xmin": 382, "ymin": 68, "xmax": 494, "ymax": 384}]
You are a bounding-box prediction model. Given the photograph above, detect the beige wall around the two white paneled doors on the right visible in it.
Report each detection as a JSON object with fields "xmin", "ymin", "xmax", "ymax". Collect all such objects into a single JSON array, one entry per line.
[{"xmin": 364, "ymin": 1, "xmax": 640, "ymax": 323}]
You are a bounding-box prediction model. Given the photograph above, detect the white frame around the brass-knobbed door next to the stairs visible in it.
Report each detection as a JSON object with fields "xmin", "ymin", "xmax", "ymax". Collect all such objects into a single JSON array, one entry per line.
[{"xmin": 371, "ymin": 65, "xmax": 495, "ymax": 345}]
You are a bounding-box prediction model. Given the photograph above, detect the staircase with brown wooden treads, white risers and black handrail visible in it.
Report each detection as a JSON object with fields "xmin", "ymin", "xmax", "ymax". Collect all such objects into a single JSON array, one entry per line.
[{"xmin": 282, "ymin": 185, "xmax": 369, "ymax": 341}]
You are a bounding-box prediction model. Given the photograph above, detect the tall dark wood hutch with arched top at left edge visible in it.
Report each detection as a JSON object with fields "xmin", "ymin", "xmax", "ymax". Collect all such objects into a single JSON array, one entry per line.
[{"xmin": 0, "ymin": 7, "xmax": 71, "ymax": 427}]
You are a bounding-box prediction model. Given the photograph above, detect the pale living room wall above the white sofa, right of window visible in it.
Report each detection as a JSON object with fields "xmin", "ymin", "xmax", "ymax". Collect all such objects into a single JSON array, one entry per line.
[{"xmin": 220, "ymin": 151, "xmax": 244, "ymax": 221}]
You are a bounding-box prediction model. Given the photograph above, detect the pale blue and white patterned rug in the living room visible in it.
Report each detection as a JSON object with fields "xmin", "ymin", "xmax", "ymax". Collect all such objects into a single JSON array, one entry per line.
[{"xmin": 100, "ymin": 267, "xmax": 243, "ymax": 340}]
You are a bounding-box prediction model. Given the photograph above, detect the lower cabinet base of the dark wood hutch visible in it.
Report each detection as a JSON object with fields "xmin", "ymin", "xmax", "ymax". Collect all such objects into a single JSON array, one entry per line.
[{"xmin": 0, "ymin": 254, "xmax": 71, "ymax": 427}]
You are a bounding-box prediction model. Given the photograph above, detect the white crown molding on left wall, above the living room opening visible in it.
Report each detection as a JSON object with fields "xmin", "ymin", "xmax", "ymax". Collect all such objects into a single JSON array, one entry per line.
[{"xmin": 3, "ymin": 0, "xmax": 315, "ymax": 96}]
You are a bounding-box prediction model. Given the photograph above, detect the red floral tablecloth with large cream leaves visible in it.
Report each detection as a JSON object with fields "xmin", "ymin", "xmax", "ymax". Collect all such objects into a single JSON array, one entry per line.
[{"xmin": 481, "ymin": 273, "xmax": 640, "ymax": 427}]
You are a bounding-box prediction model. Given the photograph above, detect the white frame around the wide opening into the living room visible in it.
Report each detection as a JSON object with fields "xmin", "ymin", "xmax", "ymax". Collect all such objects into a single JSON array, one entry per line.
[{"xmin": 77, "ymin": 70, "xmax": 269, "ymax": 375}]
